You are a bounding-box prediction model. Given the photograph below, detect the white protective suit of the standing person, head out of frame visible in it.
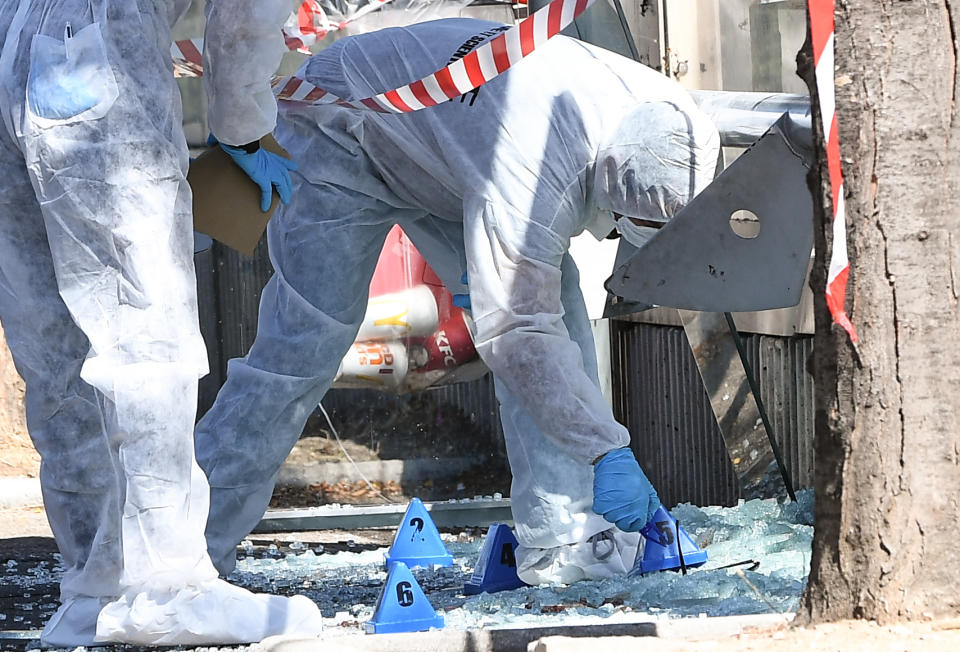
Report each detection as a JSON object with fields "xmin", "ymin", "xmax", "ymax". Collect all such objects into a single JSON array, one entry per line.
[{"xmin": 0, "ymin": 0, "xmax": 320, "ymax": 646}]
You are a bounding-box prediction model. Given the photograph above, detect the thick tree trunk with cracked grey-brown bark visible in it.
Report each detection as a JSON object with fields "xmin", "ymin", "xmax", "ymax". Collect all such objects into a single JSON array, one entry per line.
[{"xmin": 798, "ymin": 0, "xmax": 960, "ymax": 623}]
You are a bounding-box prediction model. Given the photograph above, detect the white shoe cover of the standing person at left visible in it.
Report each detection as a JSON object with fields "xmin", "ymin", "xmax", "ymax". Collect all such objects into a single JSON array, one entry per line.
[{"xmin": 96, "ymin": 580, "xmax": 322, "ymax": 645}]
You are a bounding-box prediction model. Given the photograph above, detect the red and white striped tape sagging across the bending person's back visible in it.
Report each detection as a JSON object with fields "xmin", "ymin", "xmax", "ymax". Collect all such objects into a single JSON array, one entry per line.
[{"xmin": 274, "ymin": 0, "xmax": 595, "ymax": 113}]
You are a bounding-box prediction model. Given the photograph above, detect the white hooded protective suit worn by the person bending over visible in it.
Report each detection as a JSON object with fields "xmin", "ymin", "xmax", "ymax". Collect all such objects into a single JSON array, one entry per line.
[{"xmin": 197, "ymin": 19, "xmax": 719, "ymax": 583}]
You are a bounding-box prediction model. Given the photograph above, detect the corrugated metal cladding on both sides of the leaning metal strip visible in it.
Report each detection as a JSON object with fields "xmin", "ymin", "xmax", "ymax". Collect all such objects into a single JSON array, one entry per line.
[{"xmin": 612, "ymin": 321, "xmax": 813, "ymax": 505}]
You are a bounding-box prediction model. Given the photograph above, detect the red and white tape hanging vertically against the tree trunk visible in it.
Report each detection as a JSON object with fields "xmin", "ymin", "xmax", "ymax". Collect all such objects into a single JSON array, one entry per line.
[{"xmin": 808, "ymin": 0, "xmax": 857, "ymax": 342}]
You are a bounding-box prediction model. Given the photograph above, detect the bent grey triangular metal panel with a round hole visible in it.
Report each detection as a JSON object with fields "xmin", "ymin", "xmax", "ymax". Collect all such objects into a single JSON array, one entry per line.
[{"xmin": 606, "ymin": 114, "xmax": 813, "ymax": 312}]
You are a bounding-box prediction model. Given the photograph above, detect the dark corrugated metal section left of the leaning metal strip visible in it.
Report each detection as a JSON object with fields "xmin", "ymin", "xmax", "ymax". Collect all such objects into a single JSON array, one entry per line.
[{"xmin": 613, "ymin": 322, "xmax": 740, "ymax": 506}]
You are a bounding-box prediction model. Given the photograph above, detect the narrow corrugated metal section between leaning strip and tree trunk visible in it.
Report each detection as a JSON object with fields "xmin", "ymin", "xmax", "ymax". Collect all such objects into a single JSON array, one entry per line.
[{"xmin": 743, "ymin": 335, "xmax": 814, "ymax": 488}]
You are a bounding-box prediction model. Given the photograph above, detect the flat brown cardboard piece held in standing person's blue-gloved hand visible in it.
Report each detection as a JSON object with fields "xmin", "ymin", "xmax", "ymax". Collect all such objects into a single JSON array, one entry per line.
[{"xmin": 187, "ymin": 134, "xmax": 290, "ymax": 256}]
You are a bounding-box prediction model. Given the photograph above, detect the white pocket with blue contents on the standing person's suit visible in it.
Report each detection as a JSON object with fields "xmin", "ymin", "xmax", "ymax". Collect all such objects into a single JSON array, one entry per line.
[{"xmin": 26, "ymin": 23, "xmax": 120, "ymax": 128}]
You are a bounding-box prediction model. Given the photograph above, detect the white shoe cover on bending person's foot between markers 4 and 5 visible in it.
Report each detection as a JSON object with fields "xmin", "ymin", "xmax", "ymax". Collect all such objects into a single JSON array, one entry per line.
[{"xmin": 516, "ymin": 528, "xmax": 641, "ymax": 586}]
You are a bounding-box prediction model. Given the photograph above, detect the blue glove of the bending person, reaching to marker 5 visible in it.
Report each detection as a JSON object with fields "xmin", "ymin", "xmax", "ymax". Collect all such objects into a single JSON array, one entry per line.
[{"xmin": 593, "ymin": 448, "xmax": 660, "ymax": 532}]
